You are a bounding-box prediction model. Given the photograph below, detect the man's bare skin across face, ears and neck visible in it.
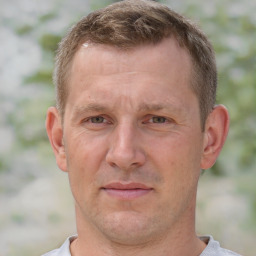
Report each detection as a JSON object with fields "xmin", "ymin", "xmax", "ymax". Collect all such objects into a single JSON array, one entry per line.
[{"xmin": 46, "ymin": 38, "xmax": 229, "ymax": 256}]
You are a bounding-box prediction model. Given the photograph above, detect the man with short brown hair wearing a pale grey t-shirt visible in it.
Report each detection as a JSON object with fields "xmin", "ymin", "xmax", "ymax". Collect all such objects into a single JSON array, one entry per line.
[{"xmin": 43, "ymin": 0, "xmax": 240, "ymax": 256}]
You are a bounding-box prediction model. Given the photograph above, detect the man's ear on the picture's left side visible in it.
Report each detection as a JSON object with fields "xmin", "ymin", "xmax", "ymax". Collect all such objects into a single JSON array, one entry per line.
[{"xmin": 45, "ymin": 107, "xmax": 67, "ymax": 171}]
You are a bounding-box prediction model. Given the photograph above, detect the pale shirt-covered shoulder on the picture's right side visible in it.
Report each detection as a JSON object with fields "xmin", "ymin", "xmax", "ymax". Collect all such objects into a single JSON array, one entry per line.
[{"xmin": 200, "ymin": 236, "xmax": 241, "ymax": 256}]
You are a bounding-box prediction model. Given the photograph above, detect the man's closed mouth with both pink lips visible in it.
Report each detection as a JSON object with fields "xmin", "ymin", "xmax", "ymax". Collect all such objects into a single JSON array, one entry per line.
[{"xmin": 102, "ymin": 182, "xmax": 153, "ymax": 200}]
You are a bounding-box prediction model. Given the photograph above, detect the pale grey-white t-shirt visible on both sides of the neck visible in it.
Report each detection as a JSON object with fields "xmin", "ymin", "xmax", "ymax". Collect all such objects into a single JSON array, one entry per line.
[{"xmin": 42, "ymin": 236, "xmax": 241, "ymax": 256}]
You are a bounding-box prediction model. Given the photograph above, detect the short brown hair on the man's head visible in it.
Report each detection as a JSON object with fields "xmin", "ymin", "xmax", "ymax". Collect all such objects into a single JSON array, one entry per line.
[{"xmin": 54, "ymin": 0, "xmax": 217, "ymax": 129}]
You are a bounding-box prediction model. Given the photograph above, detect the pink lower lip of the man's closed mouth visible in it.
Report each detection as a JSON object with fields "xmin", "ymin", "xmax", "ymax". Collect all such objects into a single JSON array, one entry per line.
[{"xmin": 104, "ymin": 188, "xmax": 152, "ymax": 200}]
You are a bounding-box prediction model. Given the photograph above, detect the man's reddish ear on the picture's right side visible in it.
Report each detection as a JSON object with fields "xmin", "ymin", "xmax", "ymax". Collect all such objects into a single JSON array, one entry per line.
[{"xmin": 201, "ymin": 105, "xmax": 229, "ymax": 169}]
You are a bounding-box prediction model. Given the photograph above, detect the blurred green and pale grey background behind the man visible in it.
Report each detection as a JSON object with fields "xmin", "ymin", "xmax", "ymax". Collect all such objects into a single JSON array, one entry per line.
[{"xmin": 0, "ymin": 0, "xmax": 256, "ymax": 256}]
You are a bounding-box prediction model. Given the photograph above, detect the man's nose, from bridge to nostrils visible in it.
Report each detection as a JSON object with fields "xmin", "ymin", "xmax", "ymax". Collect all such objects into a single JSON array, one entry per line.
[{"xmin": 106, "ymin": 122, "xmax": 146, "ymax": 171}]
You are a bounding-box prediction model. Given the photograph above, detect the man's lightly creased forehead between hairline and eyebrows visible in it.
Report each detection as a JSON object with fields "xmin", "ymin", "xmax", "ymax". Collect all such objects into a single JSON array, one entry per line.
[{"xmin": 67, "ymin": 38, "xmax": 195, "ymax": 114}]
